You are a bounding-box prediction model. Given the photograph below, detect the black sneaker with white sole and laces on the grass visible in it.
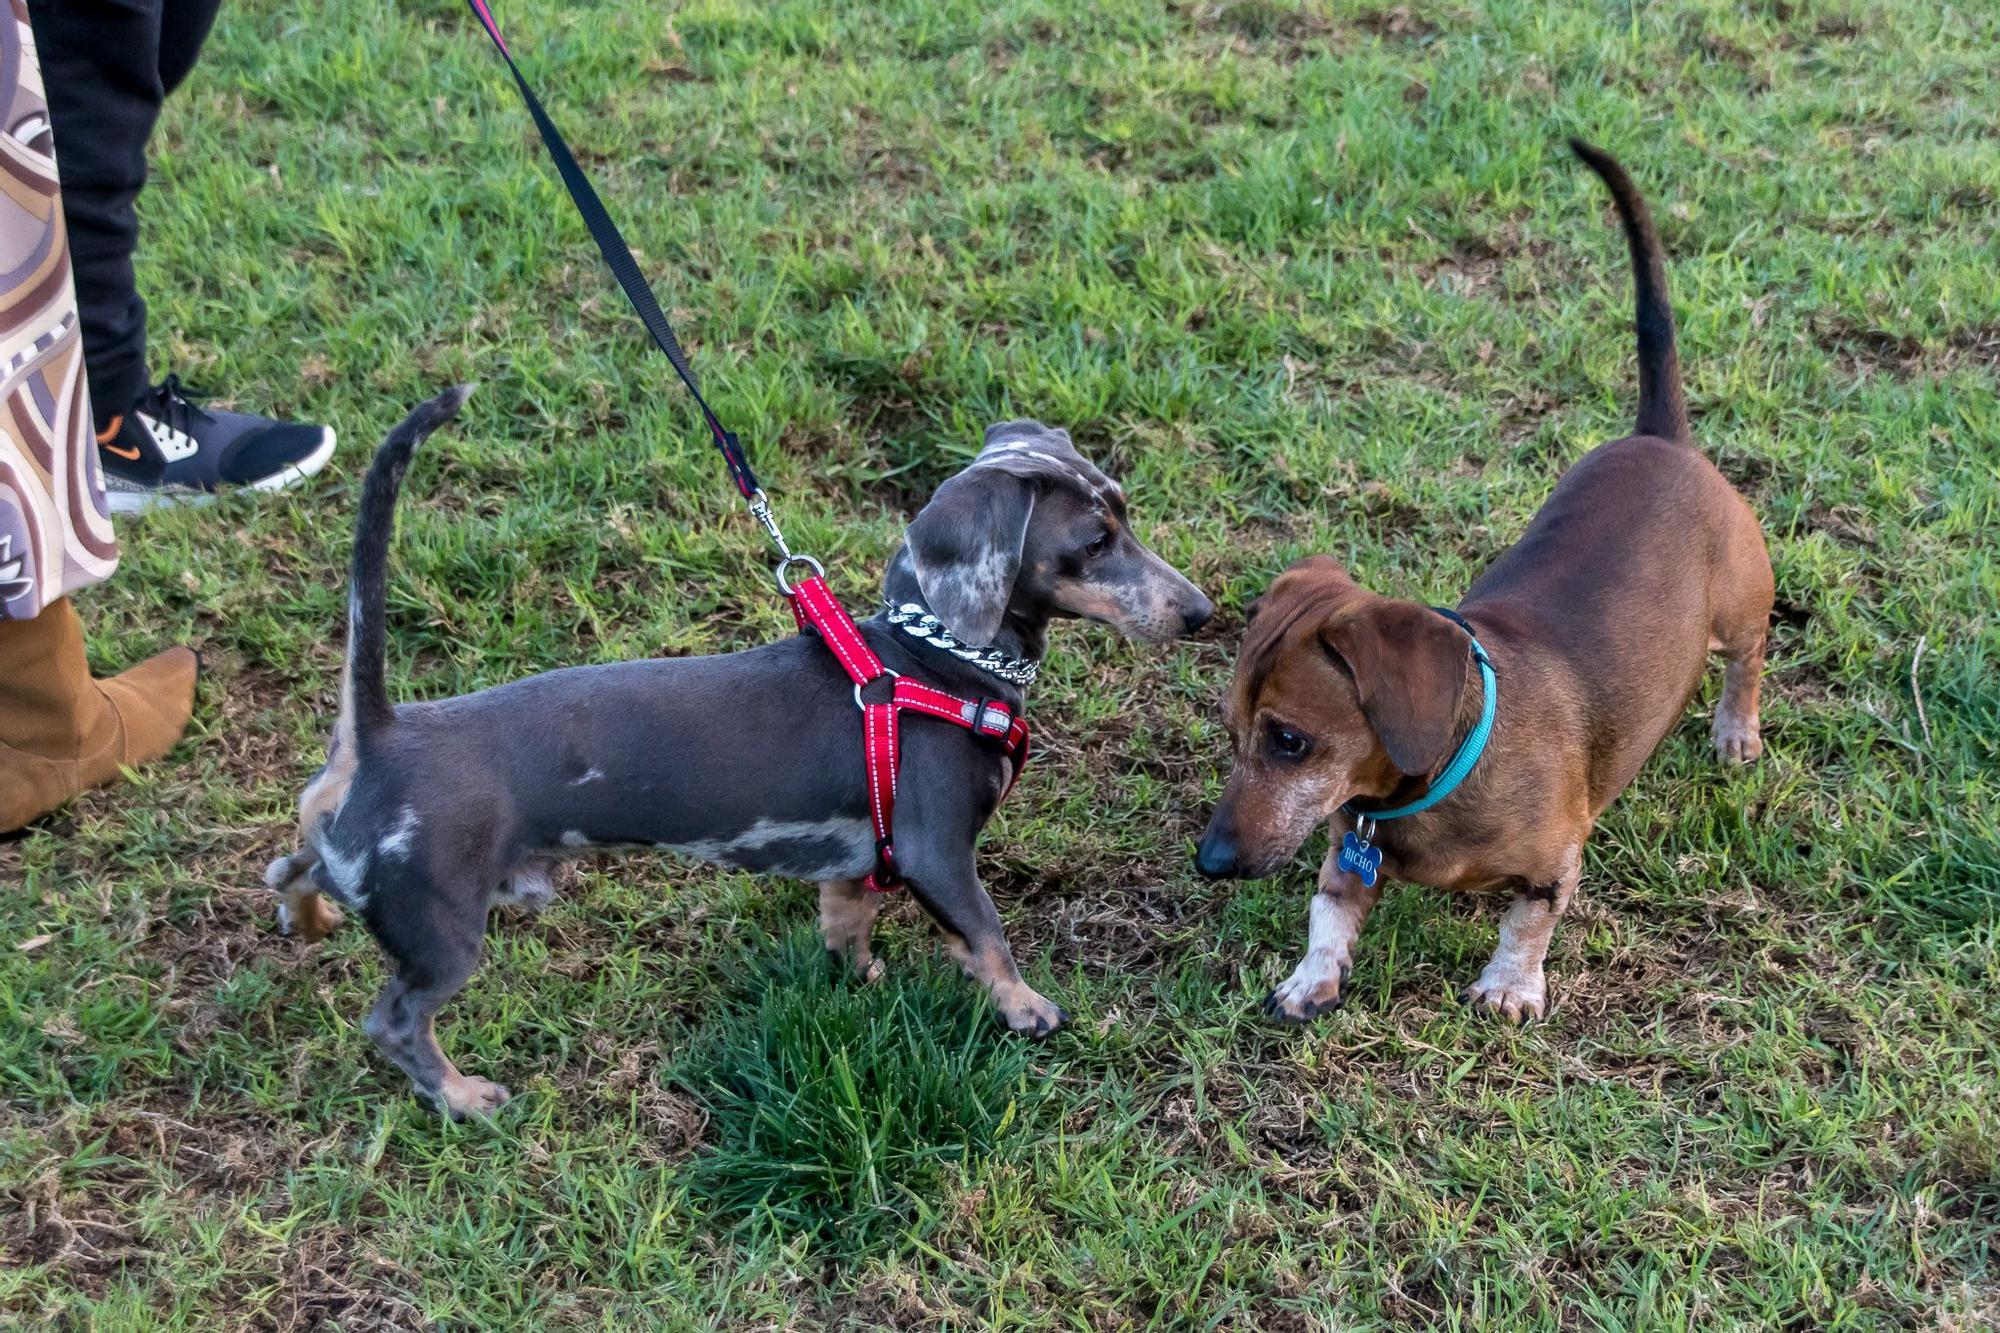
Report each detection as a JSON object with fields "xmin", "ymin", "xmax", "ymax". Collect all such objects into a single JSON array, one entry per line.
[{"xmin": 98, "ymin": 374, "xmax": 334, "ymax": 514}]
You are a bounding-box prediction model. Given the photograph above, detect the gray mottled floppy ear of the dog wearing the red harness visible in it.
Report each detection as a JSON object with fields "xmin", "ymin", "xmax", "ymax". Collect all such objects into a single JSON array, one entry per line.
[{"xmin": 906, "ymin": 466, "xmax": 1034, "ymax": 648}]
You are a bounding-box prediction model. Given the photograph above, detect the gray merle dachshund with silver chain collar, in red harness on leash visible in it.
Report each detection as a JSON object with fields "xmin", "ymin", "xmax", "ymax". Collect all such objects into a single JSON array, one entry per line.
[{"xmin": 264, "ymin": 388, "xmax": 1212, "ymax": 1115}]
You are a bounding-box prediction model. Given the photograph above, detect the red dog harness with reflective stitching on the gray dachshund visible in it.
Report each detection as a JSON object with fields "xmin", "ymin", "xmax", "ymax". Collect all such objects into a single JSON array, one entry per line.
[{"xmin": 790, "ymin": 574, "xmax": 1028, "ymax": 893}]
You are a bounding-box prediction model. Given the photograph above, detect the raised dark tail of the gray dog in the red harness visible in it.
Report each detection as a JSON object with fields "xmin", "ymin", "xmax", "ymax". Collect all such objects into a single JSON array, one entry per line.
[{"xmin": 334, "ymin": 384, "xmax": 472, "ymax": 745}]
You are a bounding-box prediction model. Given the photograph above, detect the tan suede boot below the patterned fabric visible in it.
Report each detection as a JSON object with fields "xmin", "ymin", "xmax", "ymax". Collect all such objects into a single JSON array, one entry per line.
[{"xmin": 0, "ymin": 596, "xmax": 202, "ymax": 833}]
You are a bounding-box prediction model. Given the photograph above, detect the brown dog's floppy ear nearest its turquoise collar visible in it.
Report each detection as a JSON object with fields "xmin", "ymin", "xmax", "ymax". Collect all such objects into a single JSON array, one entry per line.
[{"xmin": 1320, "ymin": 598, "xmax": 1472, "ymax": 777}]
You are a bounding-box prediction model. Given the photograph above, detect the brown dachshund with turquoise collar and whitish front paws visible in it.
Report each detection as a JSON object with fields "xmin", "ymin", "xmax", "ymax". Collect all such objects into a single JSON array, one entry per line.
[{"xmin": 1196, "ymin": 140, "xmax": 1772, "ymax": 1023}]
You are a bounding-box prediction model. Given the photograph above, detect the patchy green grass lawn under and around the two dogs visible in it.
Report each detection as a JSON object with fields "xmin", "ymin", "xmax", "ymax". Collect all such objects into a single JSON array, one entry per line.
[{"xmin": 0, "ymin": 0, "xmax": 2000, "ymax": 1331}]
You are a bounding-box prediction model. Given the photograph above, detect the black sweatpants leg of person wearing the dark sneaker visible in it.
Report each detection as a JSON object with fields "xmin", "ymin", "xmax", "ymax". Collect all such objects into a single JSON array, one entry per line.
[{"xmin": 28, "ymin": 0, "xmax": 222, "ymax": 430}]
